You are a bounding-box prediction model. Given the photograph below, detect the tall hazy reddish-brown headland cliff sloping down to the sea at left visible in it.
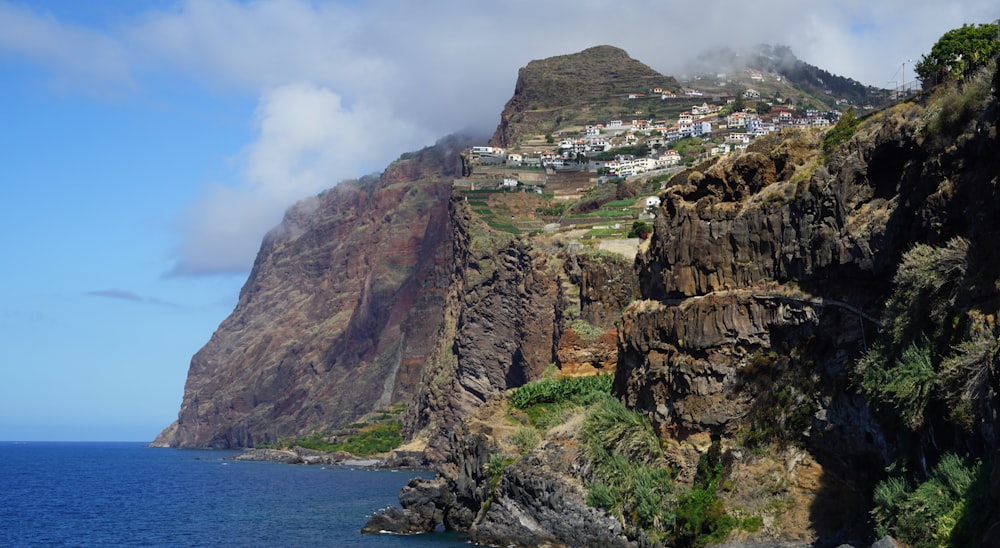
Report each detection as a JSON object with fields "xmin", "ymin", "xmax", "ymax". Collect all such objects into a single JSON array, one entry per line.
[{"xmin": 154, "ymin": 138, "xmax": 469, "ymax": 448}]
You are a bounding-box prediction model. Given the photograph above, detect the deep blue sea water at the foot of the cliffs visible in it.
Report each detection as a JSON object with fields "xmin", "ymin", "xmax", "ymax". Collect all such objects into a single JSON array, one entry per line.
[{"xmin": 0, "ymin": 442, "xmax": 468, "ymax": 548}]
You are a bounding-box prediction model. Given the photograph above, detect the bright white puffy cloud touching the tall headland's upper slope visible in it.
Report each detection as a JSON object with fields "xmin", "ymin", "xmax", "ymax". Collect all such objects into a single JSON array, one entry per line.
[{"xmin": 173, "ymin": 83, "xmax": 432, "ymax": 275}]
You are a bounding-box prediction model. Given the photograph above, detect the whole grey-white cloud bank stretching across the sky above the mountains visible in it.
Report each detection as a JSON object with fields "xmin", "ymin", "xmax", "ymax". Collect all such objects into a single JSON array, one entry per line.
[{"xmin": 0, "ymin": 0, "xmax": 1000, "ymax": 275}]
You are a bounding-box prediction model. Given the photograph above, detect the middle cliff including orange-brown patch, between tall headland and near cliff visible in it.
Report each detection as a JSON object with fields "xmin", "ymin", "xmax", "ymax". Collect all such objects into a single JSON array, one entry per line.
[{"xmin": 405, "ymin": 198, "xmax": 635, "ymax": 462}]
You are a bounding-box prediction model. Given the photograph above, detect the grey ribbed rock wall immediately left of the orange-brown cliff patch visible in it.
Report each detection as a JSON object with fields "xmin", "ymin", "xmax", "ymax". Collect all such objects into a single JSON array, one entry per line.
[{"xmin": 406, "ymin": 203, "xmax": 562, "ymax": 462}]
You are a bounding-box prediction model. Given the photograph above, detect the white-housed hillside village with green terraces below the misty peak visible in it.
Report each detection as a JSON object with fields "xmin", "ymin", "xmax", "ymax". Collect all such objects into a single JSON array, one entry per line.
[{"xmin": 455, "ymin": 65, "xmax": 847, "ymax": 255}]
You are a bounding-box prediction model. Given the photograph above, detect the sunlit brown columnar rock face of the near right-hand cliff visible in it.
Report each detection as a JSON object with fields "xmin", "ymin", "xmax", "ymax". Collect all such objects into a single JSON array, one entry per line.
[{"xmin": 618, "ymin": 127, "xmax": 898, "ymax": 453}]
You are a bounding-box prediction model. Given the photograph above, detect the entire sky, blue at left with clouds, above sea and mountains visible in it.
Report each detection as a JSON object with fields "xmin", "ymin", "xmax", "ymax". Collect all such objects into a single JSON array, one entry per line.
[{"xmin": 0, "ymin": 0, "xmax": 1000, "ymax": 440}]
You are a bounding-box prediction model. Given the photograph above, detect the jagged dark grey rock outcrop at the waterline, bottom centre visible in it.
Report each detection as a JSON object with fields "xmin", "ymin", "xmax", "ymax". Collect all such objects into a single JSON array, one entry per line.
[{"xmin": 362, "ymin": 414, "xmax": 649, "ymax": 547}]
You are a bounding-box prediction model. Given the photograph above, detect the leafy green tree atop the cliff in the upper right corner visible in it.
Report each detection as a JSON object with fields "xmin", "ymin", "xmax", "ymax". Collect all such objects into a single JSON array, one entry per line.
[{"xmin": 915, "ymin": 24, "xmax": 1000, "ymax": 88}]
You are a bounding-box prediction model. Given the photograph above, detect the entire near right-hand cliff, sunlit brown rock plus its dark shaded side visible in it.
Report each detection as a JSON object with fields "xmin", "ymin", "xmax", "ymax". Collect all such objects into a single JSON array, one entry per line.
[{"xmin": 615, "ymin": 70, "xmax": 1000, "ymax": 542}]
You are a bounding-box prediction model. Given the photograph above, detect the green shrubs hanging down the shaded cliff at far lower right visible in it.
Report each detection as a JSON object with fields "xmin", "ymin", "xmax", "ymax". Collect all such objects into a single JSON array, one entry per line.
[{"xmin": 857, "ymin": 238, "xmax": 1000, "ymax": 547}]
